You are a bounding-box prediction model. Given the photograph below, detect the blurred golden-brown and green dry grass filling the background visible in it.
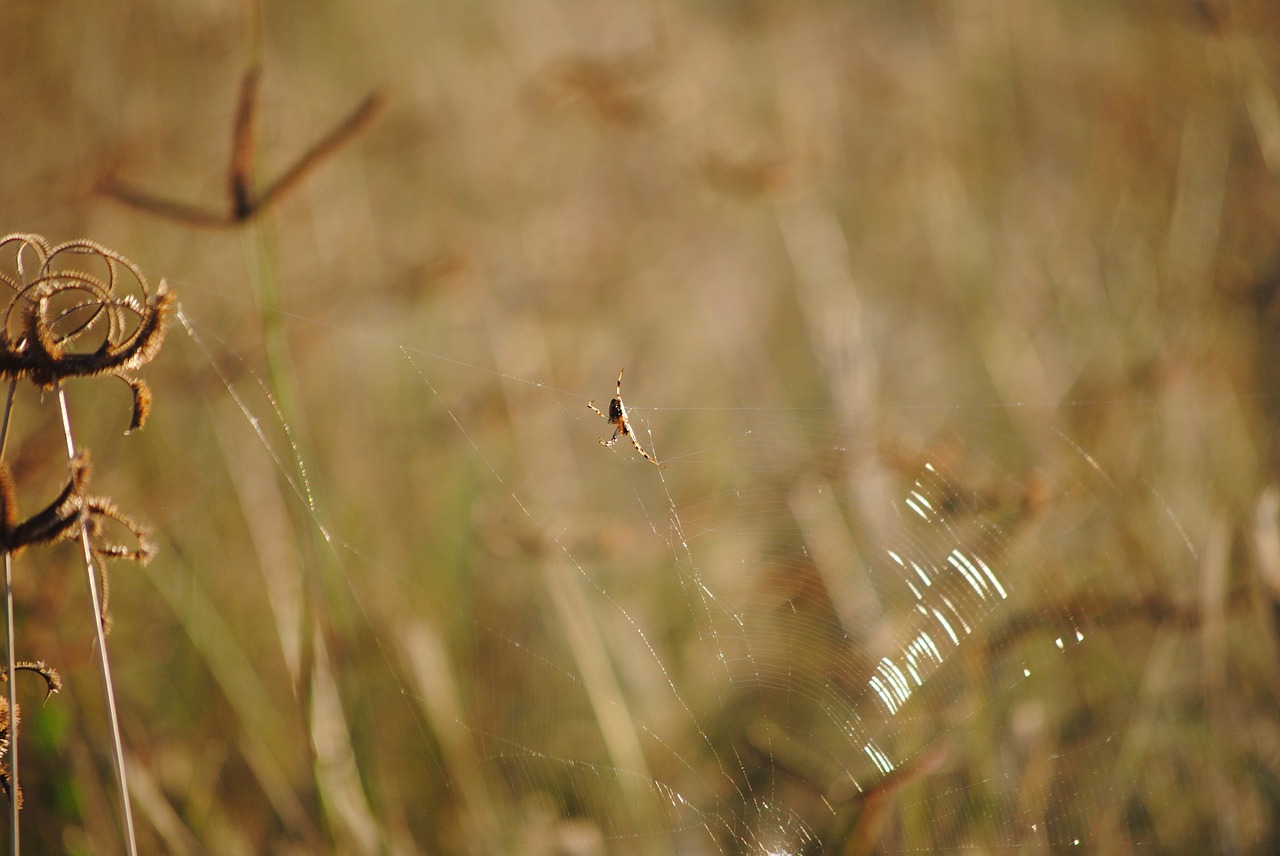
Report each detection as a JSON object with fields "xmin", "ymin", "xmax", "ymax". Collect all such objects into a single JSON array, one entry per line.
[{"xmin": 0, "ymin": 0, "xmax": 1280, "ymax": 853}]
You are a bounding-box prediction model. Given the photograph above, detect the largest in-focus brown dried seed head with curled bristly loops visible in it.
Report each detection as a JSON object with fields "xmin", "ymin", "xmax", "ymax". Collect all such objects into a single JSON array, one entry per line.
[{"xmin": 0, "ymin": 234, "xmax": 174, "ymax": 431}]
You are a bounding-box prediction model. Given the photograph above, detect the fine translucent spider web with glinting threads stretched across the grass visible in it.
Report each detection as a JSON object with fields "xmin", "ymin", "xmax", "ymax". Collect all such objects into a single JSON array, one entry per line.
[{"xmin": 154, "ymin": 291, "xmax": 1223, "ymax": 853}]
